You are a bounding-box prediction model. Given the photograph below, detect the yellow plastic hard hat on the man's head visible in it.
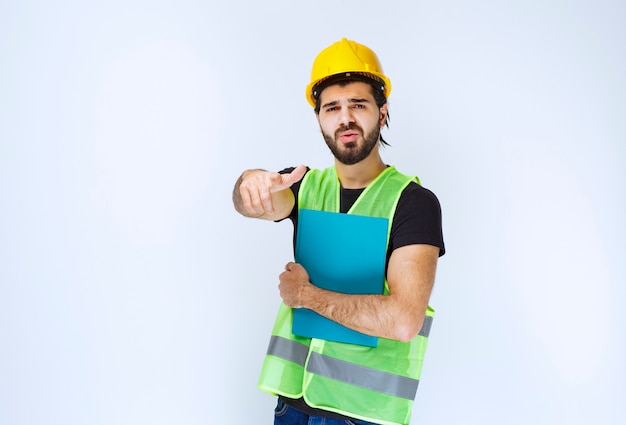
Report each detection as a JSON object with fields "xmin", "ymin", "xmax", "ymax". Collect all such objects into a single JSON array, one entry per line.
[{"xmin": 306, "ymin": 38, "xmax": 391, "ymax": 107}]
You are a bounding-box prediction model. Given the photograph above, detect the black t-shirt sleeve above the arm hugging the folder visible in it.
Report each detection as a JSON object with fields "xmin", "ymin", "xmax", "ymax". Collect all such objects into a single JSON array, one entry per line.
[{"xmin": 388, "ymin": 182, "xmax": 446, "ymax": 256}]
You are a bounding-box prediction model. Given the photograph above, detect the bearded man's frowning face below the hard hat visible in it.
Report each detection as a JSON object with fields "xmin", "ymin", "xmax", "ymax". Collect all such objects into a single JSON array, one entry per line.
[{"xmin": 317, "ymin": 81, "xmax": 387, "ymax": 165}]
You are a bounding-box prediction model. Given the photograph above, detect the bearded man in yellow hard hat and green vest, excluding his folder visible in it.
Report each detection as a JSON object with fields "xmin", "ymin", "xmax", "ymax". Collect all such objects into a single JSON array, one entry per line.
[{"xmin": 233, "ymin": 38, "xmax": 445, "ymax": 424}]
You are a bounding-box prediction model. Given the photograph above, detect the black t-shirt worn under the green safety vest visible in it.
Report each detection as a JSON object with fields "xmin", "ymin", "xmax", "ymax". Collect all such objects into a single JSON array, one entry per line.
[{"xmin": 280, "ymin": 167, "xmax": 446, "ymax": 419}]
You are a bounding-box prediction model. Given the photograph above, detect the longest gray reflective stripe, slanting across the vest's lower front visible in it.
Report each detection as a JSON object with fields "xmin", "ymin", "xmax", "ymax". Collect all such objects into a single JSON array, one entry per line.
[{"xmin": 307, "ymin": 352, "xmax": 419, "ymax": 400}]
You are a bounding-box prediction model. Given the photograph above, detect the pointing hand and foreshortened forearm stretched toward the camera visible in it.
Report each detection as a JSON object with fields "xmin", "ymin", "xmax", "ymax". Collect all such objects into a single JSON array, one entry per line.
[{"xmin": 233, "ymin": 165, "xmax": 306, "ymax": 220}]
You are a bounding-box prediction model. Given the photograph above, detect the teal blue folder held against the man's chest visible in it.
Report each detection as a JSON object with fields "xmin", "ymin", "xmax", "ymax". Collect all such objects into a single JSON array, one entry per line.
[{"xmin": 292, "ymin": 209, "xmax": 389, "ymax": 347}]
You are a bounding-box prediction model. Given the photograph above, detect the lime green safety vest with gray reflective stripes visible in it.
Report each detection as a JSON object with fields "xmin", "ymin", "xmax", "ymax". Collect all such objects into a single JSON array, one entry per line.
[{"xmin": 259, "ymin": 167, "xmax": 434, "ymax": 425}]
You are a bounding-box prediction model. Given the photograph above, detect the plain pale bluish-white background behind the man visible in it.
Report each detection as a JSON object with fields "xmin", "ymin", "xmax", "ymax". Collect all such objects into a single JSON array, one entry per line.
[{"xmin": 0, "ymin": 0, "xmax": 626, "ymax": 425}]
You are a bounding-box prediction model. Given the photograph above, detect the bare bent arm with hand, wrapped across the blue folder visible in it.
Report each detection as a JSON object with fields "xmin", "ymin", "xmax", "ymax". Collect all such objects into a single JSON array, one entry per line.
[{"xmin": 279, "ymin": 244, "xmax": 439, "ymax": 341}]
